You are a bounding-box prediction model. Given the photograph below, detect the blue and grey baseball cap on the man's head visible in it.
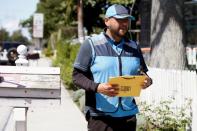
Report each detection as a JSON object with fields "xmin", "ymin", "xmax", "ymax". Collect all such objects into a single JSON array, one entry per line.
[{"xmin": 105, "ymin": 4, "xmax": 135, "ymax": 20}]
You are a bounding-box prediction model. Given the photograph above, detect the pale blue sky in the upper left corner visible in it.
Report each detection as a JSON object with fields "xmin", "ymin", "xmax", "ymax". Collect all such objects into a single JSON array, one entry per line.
[{"xmin": 0, "ymin": 0, "xmax": 39, "ymax": 39}]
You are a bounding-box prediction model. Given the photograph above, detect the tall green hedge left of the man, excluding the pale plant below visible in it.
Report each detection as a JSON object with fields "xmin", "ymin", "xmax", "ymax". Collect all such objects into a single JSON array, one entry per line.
[{"xmin": 53, "ymin": 40, "xmax": 80, "ymax": 90}]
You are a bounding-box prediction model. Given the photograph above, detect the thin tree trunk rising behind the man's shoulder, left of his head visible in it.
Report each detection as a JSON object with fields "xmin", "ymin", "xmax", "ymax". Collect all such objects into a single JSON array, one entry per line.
[{"xmin": 77, "ymin": 0, "xmax": 84, "ymax": 43}]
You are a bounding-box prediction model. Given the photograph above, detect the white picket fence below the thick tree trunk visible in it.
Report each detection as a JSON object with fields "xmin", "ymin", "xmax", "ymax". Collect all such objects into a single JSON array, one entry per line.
[{"xmin": 140, "ymin": 68, "xmax": 197, "ymax": 131}]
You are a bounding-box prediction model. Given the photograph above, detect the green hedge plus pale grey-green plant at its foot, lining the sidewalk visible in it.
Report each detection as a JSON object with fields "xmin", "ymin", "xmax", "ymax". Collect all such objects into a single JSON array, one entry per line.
[{"xmin": 53, "ymin": 40, "xmax": 85, "ymax": 112}]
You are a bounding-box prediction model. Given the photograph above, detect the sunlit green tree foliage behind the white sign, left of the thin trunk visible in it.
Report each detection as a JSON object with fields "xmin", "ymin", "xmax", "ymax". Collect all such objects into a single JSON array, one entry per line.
[{"xmin": 21, "ymin": 0, "xmax": 77, "ymax": 39}]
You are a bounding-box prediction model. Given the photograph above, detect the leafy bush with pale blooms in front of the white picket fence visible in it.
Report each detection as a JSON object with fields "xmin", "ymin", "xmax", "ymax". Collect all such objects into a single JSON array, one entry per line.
[{"xmin": 139, "ymin": 98, "xmax": 191, "ymax": 131}]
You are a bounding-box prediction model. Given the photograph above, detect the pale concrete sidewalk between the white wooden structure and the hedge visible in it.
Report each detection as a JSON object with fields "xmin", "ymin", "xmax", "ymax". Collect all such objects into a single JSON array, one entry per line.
[{"xmin": 27, "ymin": 59, "xmax": 87, "ymax": 131}]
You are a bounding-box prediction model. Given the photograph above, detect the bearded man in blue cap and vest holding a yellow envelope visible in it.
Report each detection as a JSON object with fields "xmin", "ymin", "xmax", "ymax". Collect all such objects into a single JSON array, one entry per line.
[{"xmin": 73, "ymin": 4, "xmax": 152, "ymax": 131}]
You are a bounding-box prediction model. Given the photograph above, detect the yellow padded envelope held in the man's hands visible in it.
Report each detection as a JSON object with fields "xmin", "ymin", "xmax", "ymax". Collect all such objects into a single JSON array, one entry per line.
[{"xmin": 108, "ymin": 75, "xmax": 146, "ymax": 97}]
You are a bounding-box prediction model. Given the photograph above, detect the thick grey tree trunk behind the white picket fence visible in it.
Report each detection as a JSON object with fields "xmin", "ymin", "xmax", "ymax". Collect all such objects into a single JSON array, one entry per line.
[{"xmin": 150, "ymin": 0, "xmax": 186, "ymax": 69}]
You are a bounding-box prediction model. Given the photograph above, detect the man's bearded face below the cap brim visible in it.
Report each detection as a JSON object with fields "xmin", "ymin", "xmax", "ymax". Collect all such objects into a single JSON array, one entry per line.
[{"xmin": 105, "ymin": 17, "xmax": 129, "ymax": 37}]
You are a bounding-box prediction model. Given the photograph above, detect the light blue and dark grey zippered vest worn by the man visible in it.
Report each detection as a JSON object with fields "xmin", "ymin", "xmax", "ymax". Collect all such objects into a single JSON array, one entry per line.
[{"xmin": 89, "ymin": 33, "xmax": 143, "ymax": 117}]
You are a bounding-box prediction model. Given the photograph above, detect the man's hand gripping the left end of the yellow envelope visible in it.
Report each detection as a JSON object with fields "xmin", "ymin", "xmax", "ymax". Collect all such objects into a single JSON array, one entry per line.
[{"xmin": 97, "ymin": 83, "xmax": 119, "ymax": 97}]
